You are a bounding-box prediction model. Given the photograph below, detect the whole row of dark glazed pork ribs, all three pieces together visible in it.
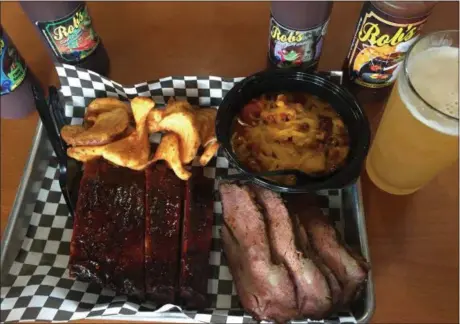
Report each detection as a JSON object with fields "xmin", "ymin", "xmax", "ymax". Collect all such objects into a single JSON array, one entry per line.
[{"xmin": 69, "ymin": 159, "xmax": 214, "ymax": 309}]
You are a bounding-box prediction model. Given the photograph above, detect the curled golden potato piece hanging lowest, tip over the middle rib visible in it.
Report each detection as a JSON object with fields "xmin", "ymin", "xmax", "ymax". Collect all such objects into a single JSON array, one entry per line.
[{"xmin": 152, "ymin": 133, "xmax": 192, "ymax": 181}]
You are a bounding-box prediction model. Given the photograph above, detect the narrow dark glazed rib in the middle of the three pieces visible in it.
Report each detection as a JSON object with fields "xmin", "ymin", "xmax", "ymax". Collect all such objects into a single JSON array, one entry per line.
[{"xmin": 145, "ymin": 163, "xmax": 185, "ymax": 304}]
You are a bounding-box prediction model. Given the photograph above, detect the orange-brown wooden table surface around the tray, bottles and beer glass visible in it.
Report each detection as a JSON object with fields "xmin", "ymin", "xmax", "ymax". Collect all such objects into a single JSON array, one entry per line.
[{"xmin": 1, "ymin": 2, "xmax": 459, "ymax": 323}]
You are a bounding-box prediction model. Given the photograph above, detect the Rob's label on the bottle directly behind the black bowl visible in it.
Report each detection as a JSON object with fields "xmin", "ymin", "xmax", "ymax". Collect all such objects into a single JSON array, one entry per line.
[{"xmin": 268, "ymin": 16, "xmax": 329, "ymax": 68}]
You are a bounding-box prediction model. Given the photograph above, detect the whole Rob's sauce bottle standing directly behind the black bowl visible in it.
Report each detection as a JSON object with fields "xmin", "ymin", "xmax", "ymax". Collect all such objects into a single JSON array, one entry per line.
[{"xmin": 267, "ymin": 1, "xmax": 333, "ymax": 72}]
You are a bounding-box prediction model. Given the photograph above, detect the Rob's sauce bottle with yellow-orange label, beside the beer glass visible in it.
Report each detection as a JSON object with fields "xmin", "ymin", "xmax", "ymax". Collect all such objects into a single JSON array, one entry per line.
[{"xmin": 342, "ymin": 1, "xmax": 436, "ymax": 103}]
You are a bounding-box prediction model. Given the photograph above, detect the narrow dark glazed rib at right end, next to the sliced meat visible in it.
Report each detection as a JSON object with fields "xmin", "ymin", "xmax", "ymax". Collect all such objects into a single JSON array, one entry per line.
[{"xmin": 179, "ymin": 168, "xmax": 214, "ymax": 309}]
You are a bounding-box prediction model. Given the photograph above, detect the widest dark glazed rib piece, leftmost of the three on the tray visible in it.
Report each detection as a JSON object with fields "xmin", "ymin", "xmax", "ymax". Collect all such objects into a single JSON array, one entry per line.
[{"xmin": 69, "ymin": 159, "xmax": 145, "ymax": 298}]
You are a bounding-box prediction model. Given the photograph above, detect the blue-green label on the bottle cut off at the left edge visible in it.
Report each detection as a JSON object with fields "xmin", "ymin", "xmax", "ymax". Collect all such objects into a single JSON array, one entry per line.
[{"xmin": 0, "ymin": 36, "xmax": 27, "ymax": 96}]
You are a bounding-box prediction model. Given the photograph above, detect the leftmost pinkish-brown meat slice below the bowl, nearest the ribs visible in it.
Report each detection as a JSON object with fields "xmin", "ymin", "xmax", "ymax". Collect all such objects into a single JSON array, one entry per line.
[{"xmin": 219, "ymin": 183, "xmax": 298, "ymax": 322}]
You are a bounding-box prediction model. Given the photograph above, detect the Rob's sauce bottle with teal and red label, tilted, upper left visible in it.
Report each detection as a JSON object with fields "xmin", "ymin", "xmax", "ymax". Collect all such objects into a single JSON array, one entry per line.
[{"xmin": 21, "ymin": 1, "xmax": 109, "ymax": 76}]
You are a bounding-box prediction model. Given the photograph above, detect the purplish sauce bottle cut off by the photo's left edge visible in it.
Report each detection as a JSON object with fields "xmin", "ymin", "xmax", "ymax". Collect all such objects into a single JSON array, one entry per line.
[{"xmin": 0, "ymin": 25, "xmax": 35, "ymax": 119}]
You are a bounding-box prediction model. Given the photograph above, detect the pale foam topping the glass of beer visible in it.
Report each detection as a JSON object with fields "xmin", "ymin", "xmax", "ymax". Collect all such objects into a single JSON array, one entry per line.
[{"xmin": 398, "ymin": 46, "xmax": 459, "ymax": 135}]
